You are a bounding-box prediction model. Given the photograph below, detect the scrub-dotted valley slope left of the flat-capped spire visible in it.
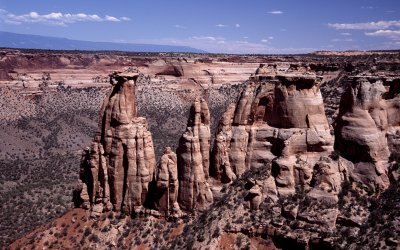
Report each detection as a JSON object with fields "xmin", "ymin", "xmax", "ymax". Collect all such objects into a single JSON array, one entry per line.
[{"xmin": 0, "ymin": 86, "xmax": 106, "ymax": 247}]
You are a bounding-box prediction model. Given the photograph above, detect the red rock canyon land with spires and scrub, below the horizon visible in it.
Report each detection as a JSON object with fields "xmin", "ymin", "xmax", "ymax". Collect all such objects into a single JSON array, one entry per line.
[{"xmin": 0, "ymin": 50, "xmax": 400, "ymax": 249}]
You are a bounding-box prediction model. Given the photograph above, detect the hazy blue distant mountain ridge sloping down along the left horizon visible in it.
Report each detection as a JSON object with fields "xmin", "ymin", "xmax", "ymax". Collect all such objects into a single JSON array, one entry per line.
[{"xmin": 0, "ymin": 31, "xmax": 207, "ymax": 53}]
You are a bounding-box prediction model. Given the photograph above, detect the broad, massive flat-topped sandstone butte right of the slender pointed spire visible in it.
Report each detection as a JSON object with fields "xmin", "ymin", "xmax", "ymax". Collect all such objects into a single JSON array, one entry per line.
[{"xmin": 212, "ymin": 65, "xmax": 333, "ymax": 194}]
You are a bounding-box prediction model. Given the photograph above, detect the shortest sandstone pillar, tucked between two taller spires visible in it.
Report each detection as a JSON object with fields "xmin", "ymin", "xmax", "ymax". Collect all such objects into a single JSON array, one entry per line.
[{"xmin": 156, "ymin": 147, "xmax": 181, "ymax": 217}]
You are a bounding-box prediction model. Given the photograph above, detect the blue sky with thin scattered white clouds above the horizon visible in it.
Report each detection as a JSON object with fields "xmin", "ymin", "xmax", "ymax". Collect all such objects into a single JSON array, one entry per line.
[{"xmin": 0, "ymin": 0, "xmax": 400, "ymax": 53}]
